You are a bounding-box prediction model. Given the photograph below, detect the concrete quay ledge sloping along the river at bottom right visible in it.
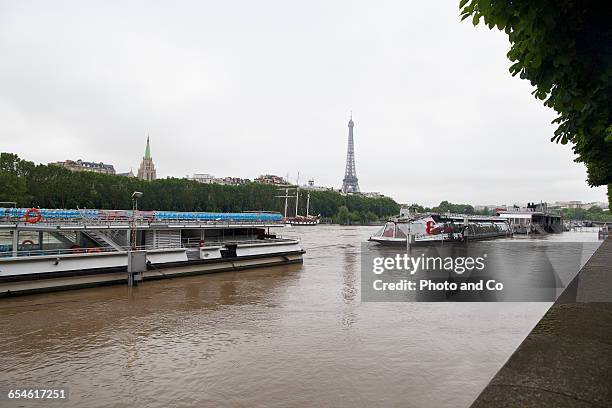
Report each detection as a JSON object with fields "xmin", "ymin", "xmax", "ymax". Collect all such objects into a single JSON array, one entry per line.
[{"xmin": 472, "ymin": 238, "xmax": 612, "ymax": 408}]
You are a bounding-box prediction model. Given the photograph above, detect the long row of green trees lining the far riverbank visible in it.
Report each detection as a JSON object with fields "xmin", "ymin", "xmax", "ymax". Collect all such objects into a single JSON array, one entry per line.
[{"xmin": 0, "ymin": 153, "xmax": 399, "ymax": 222}]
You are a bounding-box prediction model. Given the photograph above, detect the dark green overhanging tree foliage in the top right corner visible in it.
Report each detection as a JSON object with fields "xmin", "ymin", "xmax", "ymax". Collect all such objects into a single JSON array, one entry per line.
[{"xmin": 459, "ymin": 0, "xmax": 612, "ymax": 206}]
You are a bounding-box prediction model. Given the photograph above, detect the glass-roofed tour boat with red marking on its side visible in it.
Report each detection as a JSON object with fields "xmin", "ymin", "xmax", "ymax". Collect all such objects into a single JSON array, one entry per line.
[{"xmin": 369, "ymin": 214, "xmax": 512, "ymax": 246}]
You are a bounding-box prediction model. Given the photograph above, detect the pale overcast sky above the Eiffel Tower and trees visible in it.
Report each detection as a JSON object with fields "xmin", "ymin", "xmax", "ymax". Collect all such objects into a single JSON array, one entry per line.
[{"xmin": 0, "ymin": 0, "xmax": 606, "ymax": 205}]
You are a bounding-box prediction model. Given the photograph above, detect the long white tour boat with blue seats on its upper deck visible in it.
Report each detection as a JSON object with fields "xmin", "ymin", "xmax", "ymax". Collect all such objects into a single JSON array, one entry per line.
[{"xmin": 0, "ymin": 208, "xmax": 304, "ymax": 297}]
